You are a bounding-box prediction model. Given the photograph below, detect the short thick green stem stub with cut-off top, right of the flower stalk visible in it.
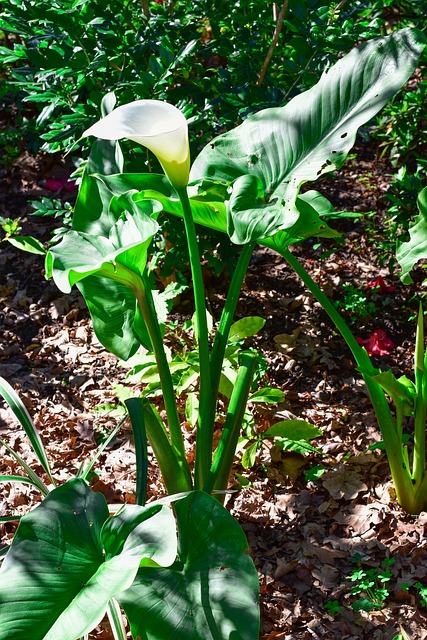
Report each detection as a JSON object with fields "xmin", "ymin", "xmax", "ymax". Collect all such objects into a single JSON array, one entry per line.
[{"xmin": 203, "ymin": 351, "xmax": 256, "ymax": 493}]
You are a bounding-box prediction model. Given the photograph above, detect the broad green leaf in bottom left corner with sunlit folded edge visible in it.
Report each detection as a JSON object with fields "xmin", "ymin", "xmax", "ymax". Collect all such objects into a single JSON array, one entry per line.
[{"xmin": 0, "ymin": 479, "xmax": 176, "ymax": 640}]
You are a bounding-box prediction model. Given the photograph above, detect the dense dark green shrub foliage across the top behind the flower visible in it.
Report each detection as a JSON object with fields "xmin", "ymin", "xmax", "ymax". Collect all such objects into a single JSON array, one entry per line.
[{"xmin": 0, "ymin": 0, "xmax": 419, "ymax": 159}]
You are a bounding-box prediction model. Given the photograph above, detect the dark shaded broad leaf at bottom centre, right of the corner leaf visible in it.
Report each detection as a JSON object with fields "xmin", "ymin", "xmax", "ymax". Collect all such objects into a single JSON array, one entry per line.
[{"xmin": 117, "ymin": 491, "xmax": 259, "ymax": 640}]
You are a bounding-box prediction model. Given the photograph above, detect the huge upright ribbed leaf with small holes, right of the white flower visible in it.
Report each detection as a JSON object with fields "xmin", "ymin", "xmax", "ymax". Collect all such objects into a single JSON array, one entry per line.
[{"xmin": 191, "ymin": 28, "xmax": 425, "ymax": 244}]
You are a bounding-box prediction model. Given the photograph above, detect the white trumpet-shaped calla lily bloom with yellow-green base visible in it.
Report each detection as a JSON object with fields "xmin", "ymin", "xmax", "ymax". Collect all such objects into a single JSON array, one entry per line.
[{"xmin": 83, "ymin": 100, "xmax": 190, "ymax": 188}]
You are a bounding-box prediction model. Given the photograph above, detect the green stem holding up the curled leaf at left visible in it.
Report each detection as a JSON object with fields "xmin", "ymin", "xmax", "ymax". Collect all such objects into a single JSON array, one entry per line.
[{"xmin": 135, "ymin": 280, "xmax": 191, "ymax": 486}]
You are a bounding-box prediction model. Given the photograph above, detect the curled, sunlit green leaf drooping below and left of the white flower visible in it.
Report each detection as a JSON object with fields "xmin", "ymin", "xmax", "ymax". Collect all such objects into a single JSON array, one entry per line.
[{"xmin": 46, "ymin": 192, "xmax": 161, "ymax": 360}]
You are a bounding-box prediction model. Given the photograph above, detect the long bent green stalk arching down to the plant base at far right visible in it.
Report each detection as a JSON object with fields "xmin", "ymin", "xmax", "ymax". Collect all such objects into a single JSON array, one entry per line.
[{"xmin": 280, "ymin": 249, "xmax": 415, "ymax": 513}]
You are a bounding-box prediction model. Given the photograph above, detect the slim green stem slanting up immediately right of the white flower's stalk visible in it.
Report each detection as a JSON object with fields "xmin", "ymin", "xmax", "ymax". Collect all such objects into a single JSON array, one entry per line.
[{"xmin": 211, "ymin": 242, "xmax": 255, "ymax": 420}]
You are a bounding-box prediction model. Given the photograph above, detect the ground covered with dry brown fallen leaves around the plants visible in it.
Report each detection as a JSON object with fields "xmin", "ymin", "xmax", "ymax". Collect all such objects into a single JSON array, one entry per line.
[{"xmin": 0, "ymin": 147, "xmax": 427, "ymax": 640}]
